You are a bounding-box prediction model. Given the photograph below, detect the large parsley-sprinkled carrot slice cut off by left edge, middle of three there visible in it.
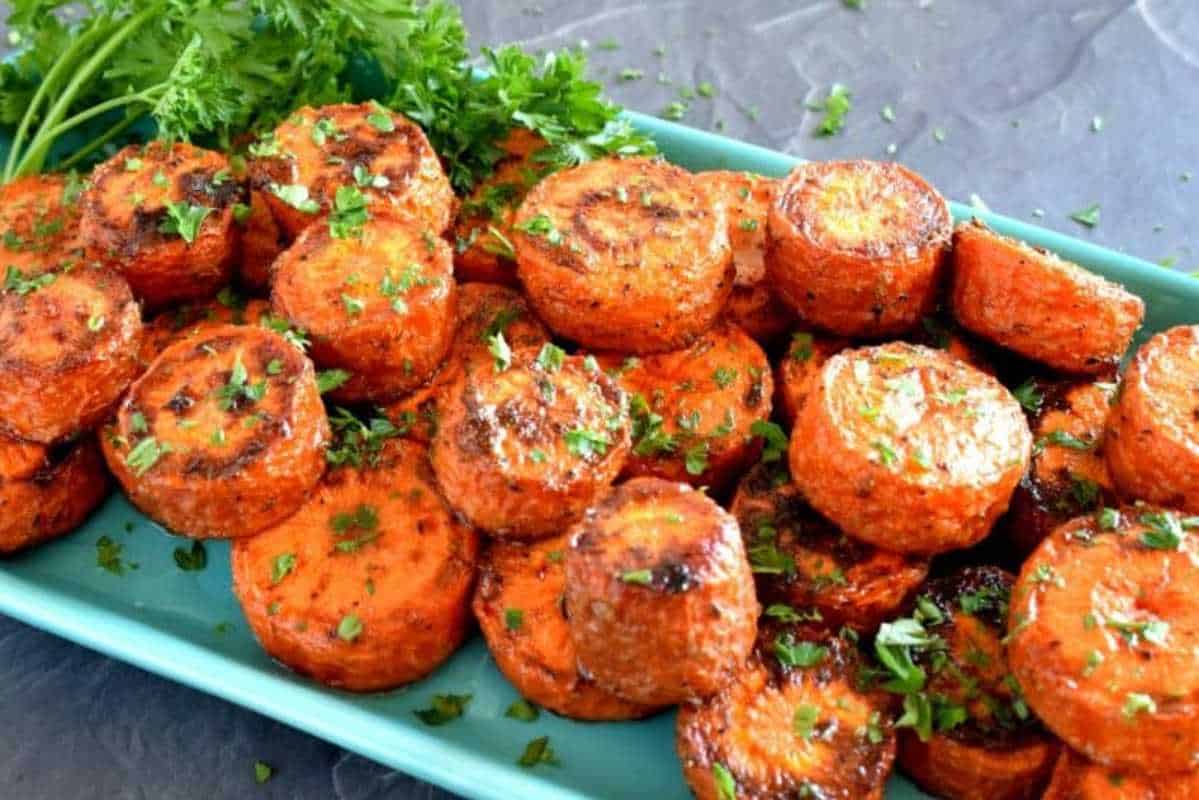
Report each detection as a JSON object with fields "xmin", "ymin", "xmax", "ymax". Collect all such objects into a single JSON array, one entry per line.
[{"xmin": 0, "ymin": 265, "xmax": 141, "ymax": 444}]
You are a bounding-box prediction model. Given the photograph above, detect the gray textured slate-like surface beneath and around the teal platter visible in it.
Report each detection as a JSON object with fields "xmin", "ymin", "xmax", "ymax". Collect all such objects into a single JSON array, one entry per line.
[{"xmin": 0, "ymin": 0, "xmax": 1199, "ymax": 800}]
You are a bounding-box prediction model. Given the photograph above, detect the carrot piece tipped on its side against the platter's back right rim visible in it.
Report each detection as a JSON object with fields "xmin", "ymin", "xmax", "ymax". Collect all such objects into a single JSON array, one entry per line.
[{"xmin": 951, "ymin": 219, "xmax": 1145, "ymax": 374}]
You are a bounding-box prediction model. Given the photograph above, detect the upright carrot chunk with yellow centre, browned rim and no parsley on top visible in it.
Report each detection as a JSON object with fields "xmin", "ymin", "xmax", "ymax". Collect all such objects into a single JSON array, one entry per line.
[{"xmin": 766, "ymin": 161, "xmax": 952, "ymax": 337}]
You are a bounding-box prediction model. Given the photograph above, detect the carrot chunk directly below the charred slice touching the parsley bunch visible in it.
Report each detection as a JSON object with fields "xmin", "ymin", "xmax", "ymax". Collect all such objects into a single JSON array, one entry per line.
[{"xmin": 271, "ymin": 212, "xmax": 457, "ymax": 403}]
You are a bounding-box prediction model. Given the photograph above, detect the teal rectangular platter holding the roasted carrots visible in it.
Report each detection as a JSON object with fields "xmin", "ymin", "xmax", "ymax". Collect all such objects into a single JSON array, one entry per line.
[{"xmin": 0, "ymin": 114, "xmax": 1199, "ymax": 800}]
